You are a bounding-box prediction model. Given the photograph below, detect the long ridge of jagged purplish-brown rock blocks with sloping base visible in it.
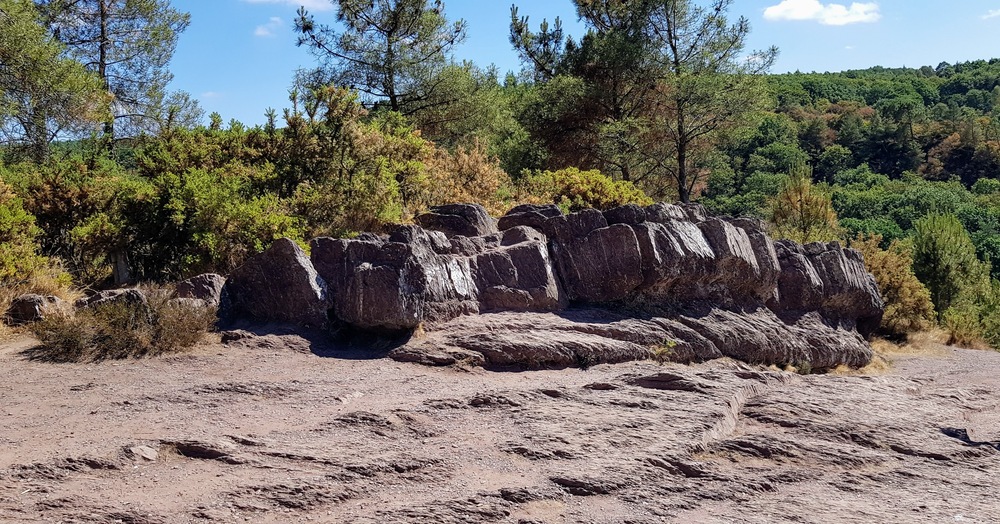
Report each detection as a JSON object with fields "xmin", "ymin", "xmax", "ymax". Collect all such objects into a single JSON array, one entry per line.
[{"xmin": 222, "ymin": 203, "xmax": 884, "ymax": 368}]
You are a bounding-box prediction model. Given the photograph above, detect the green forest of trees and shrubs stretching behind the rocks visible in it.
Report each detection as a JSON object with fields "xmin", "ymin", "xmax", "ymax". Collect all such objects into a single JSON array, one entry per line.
[{"xmin": 0, "ymin": 0, "xmax": 1000, "ymax": 346}]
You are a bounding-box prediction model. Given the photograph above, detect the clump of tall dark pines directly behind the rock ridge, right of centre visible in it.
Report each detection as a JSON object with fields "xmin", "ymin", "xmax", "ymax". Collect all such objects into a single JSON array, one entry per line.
[{"xmin": 511, "ymin": 0, "xmax": 777, "ymax": 202}]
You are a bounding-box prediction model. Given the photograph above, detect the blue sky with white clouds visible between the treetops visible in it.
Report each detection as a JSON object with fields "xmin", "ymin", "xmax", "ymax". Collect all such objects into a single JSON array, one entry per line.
[{"xmin": 171, "ymin": 0, "xmax": 1000, "ymax": 125}]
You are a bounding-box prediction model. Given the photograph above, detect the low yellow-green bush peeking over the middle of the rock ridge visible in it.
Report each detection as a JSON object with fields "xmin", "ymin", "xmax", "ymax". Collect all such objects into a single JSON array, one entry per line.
[{"xmin": 519, "ymin": 168, "xmax": 653, "ymax": 212}]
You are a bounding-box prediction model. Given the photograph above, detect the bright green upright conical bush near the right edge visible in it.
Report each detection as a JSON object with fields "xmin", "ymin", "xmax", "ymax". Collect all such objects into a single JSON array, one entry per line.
[{"xmin": 913, "ymin": 213, "xmax": 989, "ymax": 318}]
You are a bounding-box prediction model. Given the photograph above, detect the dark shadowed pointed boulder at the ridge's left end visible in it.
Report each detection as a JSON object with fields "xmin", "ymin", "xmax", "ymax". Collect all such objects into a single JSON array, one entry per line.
[{"xmin": 220, "ymin": 238, "xmax": 330, "ymax": 328}]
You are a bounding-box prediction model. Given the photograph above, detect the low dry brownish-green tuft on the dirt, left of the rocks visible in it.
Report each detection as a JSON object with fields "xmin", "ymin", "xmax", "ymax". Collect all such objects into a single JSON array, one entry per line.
[{"xmin": 27, "ymin": 288, "xmax": 216, "ymax": 362}]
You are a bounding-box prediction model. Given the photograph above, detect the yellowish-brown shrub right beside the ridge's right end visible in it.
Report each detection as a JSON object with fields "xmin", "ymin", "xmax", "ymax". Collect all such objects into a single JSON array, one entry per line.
[{"xmin": 851, "ymin": 235, "xmax": 934, "ymax": 337}]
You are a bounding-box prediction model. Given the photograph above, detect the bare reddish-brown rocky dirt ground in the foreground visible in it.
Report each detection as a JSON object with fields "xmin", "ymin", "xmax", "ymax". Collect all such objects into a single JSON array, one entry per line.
[{"xmin": 0, "ymin": 330, "xmax": 1000, "ymax": 523}]
